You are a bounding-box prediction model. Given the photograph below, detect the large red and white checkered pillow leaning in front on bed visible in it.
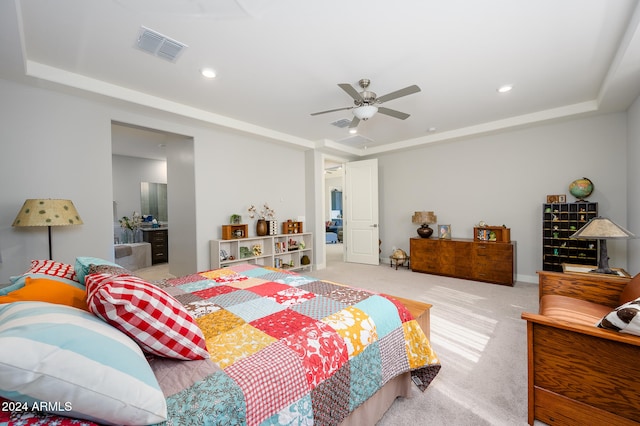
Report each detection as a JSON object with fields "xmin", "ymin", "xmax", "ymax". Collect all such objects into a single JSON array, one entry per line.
[{"xmin": 85, "ymin": 274, "xmax": 209, "ymax": 360}]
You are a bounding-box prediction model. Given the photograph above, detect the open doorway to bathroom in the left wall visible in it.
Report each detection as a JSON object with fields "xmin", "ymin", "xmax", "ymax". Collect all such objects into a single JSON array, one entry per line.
[{"xmin": 111, "ymin": 122, "xmax": 197, "ymax": 275}]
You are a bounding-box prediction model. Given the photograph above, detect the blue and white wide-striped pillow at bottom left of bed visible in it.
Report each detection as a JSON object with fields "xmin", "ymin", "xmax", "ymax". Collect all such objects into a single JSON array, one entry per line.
[{"xmin": 0, "ymin": 302, "xmax": 167, "ymax": 425}]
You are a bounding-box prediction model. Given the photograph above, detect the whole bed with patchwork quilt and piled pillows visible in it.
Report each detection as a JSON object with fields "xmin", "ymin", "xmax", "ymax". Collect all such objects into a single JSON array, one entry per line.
[{"xmin": 0, "ymin": 258, "xmax": 440, "ymax": 426}]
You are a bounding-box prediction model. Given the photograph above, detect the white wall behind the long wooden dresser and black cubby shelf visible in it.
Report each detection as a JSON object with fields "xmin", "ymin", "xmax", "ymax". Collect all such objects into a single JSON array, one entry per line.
[{"xmin": 378, "ymin": 113, "xmax": 628, "ymax": 282}]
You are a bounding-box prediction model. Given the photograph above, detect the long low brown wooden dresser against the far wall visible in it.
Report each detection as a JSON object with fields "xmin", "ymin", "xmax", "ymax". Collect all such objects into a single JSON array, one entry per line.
[{"xmin": 409, "ymin": 238, "xmax": 516, "ymax": 286}]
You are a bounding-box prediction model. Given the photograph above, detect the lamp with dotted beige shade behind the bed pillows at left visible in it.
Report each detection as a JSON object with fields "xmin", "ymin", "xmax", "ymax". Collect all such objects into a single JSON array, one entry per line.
[{"xmin": 11, "ymin": 198, "xmax": 83, "ymax": 260}]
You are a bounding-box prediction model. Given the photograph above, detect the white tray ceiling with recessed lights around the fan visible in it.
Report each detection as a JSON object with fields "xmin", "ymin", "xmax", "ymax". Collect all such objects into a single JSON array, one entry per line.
[{"xmin": 0, "ymin": 0, "xmax": 640, "ymax": 155}]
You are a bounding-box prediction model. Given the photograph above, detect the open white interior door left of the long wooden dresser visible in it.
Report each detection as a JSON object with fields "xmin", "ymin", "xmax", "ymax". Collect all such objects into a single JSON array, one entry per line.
[{"xmin": 342, "ymin": 159, "xmax": 380, "ymax": 265}]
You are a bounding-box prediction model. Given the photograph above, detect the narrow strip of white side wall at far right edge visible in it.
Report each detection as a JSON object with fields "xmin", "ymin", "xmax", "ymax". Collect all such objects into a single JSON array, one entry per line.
[{"xmin": 628, "ymin": 93, "xmax": 640, "ymax": 274}]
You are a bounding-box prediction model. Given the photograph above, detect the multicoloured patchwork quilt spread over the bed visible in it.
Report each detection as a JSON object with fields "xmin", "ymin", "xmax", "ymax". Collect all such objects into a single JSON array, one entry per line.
[{"xmin": 0, "ymin": 265, "xmax": 440, "ymax": 426}]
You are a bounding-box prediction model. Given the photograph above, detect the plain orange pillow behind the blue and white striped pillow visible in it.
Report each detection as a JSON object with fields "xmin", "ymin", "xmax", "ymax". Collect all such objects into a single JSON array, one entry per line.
[{"xmin": 0, "ymin": 277, "xmax": 89, "ymax": 311}]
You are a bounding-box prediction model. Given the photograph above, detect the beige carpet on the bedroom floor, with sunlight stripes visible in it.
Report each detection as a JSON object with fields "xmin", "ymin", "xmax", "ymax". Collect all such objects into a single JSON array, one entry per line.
[{"xmin": 307, "ymin": 244, "xmax": 541, "ymax": 426}]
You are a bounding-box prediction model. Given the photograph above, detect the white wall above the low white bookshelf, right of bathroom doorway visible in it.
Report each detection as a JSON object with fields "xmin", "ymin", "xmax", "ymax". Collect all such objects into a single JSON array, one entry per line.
[{"xmin": 191, "ymin": 126, "xmax": 306, "ymax": 270}]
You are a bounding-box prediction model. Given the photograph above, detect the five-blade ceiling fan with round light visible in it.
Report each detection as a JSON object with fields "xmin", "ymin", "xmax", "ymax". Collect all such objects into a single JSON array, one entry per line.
[{"xmin": 311, "ymin": 78, "xmax": 420, "ymax": 129}]
